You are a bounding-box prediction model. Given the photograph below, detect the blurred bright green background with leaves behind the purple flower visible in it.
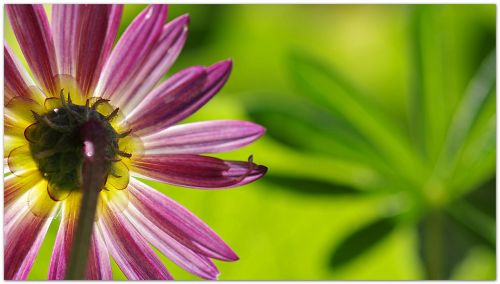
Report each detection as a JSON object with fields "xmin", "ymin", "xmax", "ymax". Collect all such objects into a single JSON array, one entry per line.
[{"xmin": 4, "ymin": 5, "xmax": 496, "ymax": 280}]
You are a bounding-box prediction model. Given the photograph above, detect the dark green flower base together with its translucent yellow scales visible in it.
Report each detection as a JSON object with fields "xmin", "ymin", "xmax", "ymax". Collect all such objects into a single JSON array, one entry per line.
[{"xmin": 9, "ymin": 83, "xmax": 140, "ymax": 201}]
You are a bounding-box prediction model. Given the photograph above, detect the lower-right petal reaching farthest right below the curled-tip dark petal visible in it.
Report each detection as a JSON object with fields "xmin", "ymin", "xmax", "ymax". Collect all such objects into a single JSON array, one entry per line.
[{"xmin": 128, "ymin": 179, "xmax": 238, "ymax": 261}]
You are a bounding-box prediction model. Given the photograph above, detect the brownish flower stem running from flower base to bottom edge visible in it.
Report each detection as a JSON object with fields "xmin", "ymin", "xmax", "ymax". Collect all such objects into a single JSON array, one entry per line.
[{"xmin": 66, "ymin": 120, "xmax": 109, "ymax": 280}]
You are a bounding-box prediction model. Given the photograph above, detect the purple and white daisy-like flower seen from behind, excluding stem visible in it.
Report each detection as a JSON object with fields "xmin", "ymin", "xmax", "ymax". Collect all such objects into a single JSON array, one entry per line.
[{"xmin": 4, "ymin": 5, "xmax": 267, "ymax": 279}]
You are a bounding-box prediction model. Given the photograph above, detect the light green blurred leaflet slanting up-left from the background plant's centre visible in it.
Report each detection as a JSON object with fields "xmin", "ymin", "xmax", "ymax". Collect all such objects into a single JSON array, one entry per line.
[{"xmin": 289, "ymin": 51, "xmax": 426, "ymax": 183}]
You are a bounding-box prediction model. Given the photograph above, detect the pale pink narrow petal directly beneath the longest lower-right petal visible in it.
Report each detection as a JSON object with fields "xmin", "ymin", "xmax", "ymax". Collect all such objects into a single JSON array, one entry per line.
[{"xmin": 125, "ymin": 204, "xmax": 219, "ymax": 280}]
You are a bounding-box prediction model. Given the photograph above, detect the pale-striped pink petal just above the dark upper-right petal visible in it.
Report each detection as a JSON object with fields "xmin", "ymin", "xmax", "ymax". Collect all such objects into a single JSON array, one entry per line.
[{"xmin": 113, "ymin": 15, "xmax": 189, "ymax": 113}]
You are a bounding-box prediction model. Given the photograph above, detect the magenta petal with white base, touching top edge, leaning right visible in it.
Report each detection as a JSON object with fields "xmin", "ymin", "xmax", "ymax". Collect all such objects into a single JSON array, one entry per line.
[{"xmin": 94, "ymin": 5, "xmax": 168, "ymax": 100}]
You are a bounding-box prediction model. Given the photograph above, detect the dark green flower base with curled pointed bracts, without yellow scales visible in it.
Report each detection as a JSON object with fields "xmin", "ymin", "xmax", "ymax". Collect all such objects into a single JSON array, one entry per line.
[{"xmin": 25, "ymin": 90, "xmax": 131, "ymax": 200}]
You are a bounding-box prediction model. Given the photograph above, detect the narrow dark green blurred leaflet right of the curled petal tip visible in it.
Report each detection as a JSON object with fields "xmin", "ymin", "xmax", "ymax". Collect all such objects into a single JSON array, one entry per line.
[{"xmin": 263, "ymin": 175, "xmax": 367, "ymax": 197}]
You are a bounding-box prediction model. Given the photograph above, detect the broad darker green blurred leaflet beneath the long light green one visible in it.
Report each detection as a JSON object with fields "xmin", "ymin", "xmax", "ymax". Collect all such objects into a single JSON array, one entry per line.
[{"xmin": 245, "ymin": 94, "xmax": 396, "ymax": 175}]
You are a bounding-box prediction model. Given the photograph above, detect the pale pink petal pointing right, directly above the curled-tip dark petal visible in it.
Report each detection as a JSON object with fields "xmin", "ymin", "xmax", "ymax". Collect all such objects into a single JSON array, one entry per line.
[{"xmin": 141, "ymin": 120, "xmax": 265, "ymax": 155}]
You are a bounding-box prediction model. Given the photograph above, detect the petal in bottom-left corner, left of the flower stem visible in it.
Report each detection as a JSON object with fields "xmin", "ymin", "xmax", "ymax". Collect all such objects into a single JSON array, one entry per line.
[{"xmin": 4, "ymin": 197, "xmax": 55, "ymax": 280}]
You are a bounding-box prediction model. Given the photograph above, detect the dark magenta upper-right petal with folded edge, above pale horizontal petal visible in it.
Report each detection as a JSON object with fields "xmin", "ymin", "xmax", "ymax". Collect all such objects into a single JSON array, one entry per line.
[{"xmin": 129, "ymin": 60, "xmax": 232, "ymax": 135}]
